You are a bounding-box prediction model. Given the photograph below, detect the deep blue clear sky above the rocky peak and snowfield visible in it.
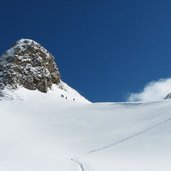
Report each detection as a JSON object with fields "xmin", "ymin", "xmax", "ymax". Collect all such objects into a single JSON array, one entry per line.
[{"xmin": 0, "ymin": 0, "xmax": 171, "ymax": 101}]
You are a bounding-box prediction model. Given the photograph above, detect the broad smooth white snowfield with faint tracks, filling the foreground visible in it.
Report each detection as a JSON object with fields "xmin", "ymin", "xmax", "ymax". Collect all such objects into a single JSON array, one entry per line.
[{"xmin": 0, "ymin": 89, "xmax": 171, "ymax": 171}]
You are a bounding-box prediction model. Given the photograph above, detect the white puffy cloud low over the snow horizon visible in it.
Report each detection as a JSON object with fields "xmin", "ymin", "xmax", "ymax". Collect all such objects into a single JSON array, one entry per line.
[{"xmin": 128, "ymin": 78, "xmax": 171, "ymax": 101}]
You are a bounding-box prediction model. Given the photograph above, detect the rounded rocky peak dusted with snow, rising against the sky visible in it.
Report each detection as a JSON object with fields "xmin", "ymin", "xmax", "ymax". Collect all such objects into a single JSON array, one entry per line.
[{"xmin": 0, "ymin": 39, "xmax": 60, "ymax": 93}]
